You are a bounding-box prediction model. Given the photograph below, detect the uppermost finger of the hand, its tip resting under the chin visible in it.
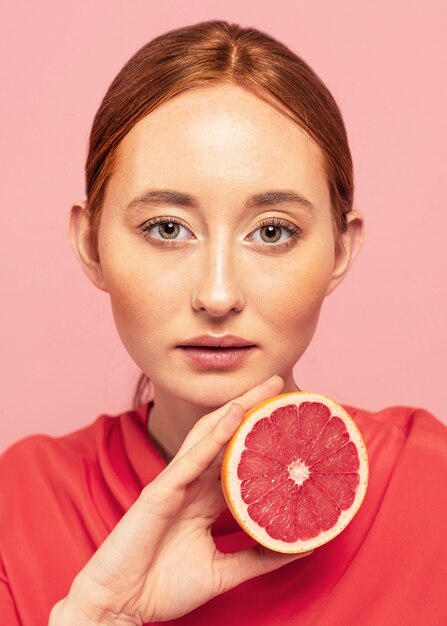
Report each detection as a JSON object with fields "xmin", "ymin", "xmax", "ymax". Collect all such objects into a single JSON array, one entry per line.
[{"xmin": 176, "ymin": 375, "xmax": 284, "ymax": 457}]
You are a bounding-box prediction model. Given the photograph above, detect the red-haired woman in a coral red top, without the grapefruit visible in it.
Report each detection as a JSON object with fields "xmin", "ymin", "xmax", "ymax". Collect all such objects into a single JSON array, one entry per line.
[{"xmin": 0, "ymin": 21, "xmax": 447, "ymax": 626}]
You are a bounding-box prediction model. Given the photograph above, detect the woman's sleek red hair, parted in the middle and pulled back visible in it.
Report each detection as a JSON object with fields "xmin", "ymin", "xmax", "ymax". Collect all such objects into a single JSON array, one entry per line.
[{"xmin": 85, "ymin": 20, "xmax": 354, "ymax": 406}]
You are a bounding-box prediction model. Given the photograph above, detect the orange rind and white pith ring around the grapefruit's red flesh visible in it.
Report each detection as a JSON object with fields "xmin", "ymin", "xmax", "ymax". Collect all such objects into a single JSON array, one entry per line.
[{"xmin": 221, "ymin": 391, "xmax": 369, "ymax": 554}]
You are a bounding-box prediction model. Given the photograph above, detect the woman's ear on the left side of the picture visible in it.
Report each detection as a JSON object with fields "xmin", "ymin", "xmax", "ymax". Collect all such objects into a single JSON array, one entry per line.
[{"xmin": 67, "ymin": 202, "xmax": 108, "ymax": 291}]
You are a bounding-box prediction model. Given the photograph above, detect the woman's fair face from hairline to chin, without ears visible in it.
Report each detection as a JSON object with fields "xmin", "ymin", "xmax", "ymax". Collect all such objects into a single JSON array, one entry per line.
[{"xmin": 91, "ymin": 85, "xmax": 356, "ymax": 406}]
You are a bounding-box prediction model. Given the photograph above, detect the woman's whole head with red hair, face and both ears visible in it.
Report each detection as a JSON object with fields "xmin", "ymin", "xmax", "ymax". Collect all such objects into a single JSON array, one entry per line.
[{"xmin": 70, "ymin": 22, "xmax": 362, "ymax": 406}]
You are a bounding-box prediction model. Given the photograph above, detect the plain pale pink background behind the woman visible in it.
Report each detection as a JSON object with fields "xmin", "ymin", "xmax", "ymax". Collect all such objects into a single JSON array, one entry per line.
[{"xmin": 0, "ymin": 0, "xmax": 447, "ymax": 449}]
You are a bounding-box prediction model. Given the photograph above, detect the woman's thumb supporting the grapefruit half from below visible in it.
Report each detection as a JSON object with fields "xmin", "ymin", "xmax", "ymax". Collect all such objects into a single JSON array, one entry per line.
[{"xmin": 219, "ymin": 546, "xmax": 315, "ymax": 593}]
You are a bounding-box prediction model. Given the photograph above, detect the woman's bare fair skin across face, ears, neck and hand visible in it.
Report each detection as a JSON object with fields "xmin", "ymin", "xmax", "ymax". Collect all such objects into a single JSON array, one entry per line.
[{"xmin": 57, "ymin": 84, "xmax": 363, "ymax": 626}]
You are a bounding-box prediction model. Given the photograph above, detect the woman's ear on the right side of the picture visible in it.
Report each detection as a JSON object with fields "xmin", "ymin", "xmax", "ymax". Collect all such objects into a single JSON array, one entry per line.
[{"xmin": 326, "ymin": 210, "xmax": 364, "ymax": 296}]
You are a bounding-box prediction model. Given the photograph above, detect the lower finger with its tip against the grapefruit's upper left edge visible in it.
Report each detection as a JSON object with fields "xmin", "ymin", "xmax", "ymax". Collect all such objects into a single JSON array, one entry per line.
[{"xmin": 156, "ymin": 402, "xmax": 244, "ymax": 491}]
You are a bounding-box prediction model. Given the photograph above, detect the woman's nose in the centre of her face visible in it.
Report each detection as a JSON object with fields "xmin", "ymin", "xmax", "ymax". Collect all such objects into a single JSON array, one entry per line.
[{"xmin": 192, "ymin": 238, "xmax": 244, "ymax": 317}]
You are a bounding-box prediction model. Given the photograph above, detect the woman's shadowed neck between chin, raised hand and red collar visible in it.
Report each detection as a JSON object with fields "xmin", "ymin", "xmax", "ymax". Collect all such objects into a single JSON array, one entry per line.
[{"xmin": 148, "ymin": 372, "xmax": 300, "ymax": 463}]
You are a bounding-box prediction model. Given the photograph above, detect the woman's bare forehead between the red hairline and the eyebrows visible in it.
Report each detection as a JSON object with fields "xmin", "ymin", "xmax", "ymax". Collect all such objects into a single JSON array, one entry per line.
[{"xmin": 112, "ymin": 84, "xmax": 327, "ymax": 202}]
